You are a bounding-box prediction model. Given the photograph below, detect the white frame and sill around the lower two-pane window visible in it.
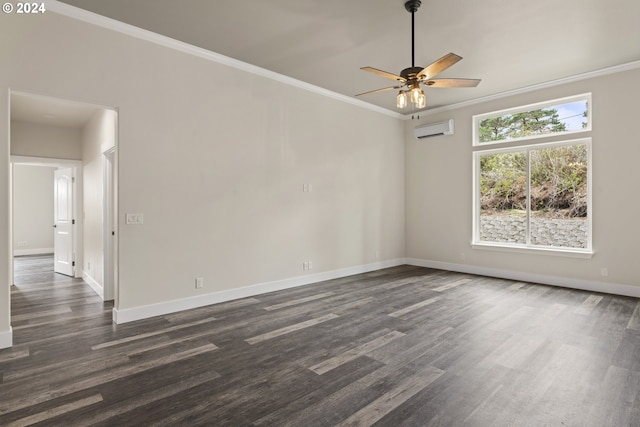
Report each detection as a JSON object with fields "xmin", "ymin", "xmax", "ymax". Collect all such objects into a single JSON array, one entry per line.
[{"xmin": 471, "ymin": 137, "xmax": 594, "ymax": 258}]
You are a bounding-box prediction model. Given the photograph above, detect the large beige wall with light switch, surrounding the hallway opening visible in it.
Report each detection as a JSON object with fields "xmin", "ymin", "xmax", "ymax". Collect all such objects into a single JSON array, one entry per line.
[{"xmin": 0, "ymin": 11, "xmax": 405, "ymax": 331}]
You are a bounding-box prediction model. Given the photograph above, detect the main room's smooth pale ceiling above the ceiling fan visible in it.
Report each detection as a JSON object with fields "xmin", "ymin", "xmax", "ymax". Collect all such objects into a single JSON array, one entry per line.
[{"xmin": 45, "ymin": 0, "xmax": 640, "ymax": 113}]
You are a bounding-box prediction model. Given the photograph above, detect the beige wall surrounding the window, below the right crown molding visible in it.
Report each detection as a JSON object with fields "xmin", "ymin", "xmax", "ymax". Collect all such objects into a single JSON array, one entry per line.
[{"xmin": 405, "ymin": 69, "xmax": 640, "ymax": 294}]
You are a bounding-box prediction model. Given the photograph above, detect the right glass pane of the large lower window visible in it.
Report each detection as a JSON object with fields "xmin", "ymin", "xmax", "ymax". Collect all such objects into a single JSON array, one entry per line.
[{"xmin": 529, "ymin": 145, "xmax": 588, "ymax": 248}]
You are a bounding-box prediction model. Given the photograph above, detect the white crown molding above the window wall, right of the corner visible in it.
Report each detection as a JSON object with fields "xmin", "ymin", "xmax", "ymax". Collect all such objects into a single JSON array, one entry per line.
[{"xmin": 410, "ymin": 61, "xmax": 640, "ymax": 120}]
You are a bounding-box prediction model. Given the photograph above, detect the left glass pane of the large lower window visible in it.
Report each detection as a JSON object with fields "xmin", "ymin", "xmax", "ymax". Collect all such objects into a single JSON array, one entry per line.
[{"xmin": 479, "ymin": 152, "xmax": 527, "ymax": 244}]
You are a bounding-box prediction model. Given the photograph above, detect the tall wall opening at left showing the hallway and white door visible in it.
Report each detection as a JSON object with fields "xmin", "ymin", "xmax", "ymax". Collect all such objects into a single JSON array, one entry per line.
[{"xmin": 8, "ymin": 91, "xmax": 117, "ymax": 338}]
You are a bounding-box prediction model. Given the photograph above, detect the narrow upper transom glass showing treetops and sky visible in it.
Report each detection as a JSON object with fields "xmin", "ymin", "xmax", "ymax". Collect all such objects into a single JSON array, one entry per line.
[{"xmin": 478, "ymin": 99, "xmax": 588, "ymax": 143}]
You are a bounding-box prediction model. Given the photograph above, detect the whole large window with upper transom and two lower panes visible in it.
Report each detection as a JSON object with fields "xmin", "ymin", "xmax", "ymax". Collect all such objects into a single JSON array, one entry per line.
[{"xmin": 473, "ymin": 95, "xmax": 591, "ymax": 254}]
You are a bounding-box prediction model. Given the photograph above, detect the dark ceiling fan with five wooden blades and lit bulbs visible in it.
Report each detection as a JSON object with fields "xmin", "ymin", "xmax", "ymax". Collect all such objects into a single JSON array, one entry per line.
[{"xmin": 356, "ymin": 0, "xmax": 480, "ymax": 109}]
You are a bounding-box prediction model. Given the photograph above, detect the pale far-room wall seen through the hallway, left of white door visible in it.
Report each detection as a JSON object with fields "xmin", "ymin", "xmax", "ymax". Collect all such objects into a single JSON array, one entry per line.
[{"xmin": 13, "ymin": 165, "xmax": 56, "ymax": 255}]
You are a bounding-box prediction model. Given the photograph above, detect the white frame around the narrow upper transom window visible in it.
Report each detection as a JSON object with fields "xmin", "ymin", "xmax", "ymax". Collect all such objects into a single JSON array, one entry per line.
[{"xmin": 472, "ymin": 92, "xmax": 593, "ymax": 147}]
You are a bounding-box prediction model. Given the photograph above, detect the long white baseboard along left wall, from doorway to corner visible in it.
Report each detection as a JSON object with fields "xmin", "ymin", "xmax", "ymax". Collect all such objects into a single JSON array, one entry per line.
[{"xmin": 113, "ymin": 258, "xmax": 405, "ymax": 324}]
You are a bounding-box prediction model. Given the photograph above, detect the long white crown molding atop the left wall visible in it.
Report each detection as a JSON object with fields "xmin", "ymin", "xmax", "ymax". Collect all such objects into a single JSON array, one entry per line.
[{"xmin": 45, "ymin": 0, "xmax": 403, "ymax": 119}]
